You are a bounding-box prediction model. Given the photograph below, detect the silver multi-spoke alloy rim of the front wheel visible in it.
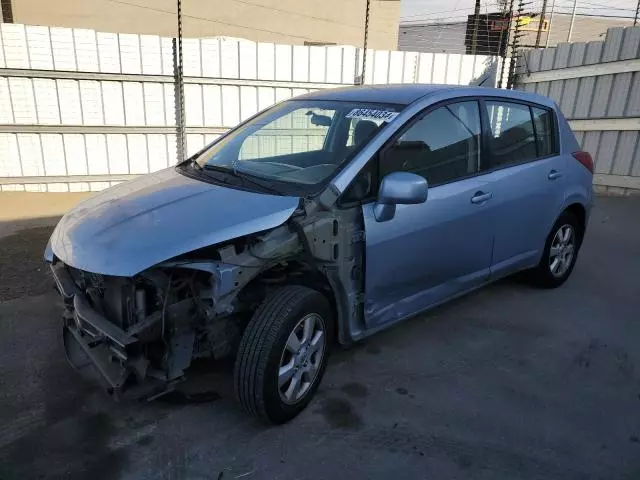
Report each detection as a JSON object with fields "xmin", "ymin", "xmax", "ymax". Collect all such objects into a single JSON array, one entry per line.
[{"xmin": 278, "ymin": 313, "xmax": 326, "ymax": 405}]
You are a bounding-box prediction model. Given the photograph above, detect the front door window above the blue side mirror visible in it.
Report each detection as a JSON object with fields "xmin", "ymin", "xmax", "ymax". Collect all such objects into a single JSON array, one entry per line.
[{"xmin": 380, "ymin": 101, "xmax": 480, "ymax": 185}]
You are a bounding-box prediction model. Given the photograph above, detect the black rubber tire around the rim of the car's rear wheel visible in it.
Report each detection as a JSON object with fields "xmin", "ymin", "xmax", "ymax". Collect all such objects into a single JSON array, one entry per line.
[{"xmin": 531, "ymin": 211, "xmax": 584, "ymax": 288}]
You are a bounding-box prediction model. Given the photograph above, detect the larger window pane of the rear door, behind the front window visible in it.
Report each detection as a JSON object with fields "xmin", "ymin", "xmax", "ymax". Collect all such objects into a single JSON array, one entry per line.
[{"xmin": 485, "ymin": 101, "xmax": 537, "ymax": 168}]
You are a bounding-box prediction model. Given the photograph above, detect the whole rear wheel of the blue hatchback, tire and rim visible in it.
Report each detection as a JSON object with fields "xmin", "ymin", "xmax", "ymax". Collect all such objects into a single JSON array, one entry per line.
[{"xmin": 532, "ymin": 212, "xmax": 584, "ymax": 288}]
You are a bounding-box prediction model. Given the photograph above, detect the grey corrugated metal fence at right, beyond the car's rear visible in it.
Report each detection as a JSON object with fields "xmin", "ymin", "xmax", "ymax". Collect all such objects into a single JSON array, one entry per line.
[{"xmin": 518, "ymin": 27, "xmax": 640, "ymax": 193}]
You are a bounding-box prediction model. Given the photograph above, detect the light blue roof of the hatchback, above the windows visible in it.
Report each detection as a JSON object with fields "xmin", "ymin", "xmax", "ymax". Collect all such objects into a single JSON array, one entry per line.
[{"xmin": 295, "ymin": 83, "xmax": 553, "ymax": 107}]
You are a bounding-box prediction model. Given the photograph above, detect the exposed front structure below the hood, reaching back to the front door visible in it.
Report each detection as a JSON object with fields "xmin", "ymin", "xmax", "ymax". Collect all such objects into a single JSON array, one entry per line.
[{"xmin": 51, "ymin": 203, "xmax": 364, "ymax": 399}]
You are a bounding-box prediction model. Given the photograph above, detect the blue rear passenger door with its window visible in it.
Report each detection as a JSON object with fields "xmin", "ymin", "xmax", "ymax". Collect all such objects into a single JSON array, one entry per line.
[{"xmin": 483, "ymin": 99, "xmax": 564, "ymax": 277}]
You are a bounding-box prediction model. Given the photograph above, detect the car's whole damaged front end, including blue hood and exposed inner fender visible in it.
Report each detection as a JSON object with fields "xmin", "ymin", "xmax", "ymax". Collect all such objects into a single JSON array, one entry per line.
[{"xmin": 44, "ymin": 166, "xmax": 365, "ymax": 399}]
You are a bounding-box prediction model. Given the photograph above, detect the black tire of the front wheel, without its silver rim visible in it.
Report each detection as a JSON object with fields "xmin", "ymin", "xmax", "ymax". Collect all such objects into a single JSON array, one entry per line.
[{"xmin": 234, "ymin": 285, "xmax": 333, "ymax": 424}]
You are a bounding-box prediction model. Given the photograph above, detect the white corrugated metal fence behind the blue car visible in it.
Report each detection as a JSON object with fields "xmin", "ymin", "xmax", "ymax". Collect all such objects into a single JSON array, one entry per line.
[{"xmin": 0, "ymin": 24, "xmax": 494, "ymax": 191}]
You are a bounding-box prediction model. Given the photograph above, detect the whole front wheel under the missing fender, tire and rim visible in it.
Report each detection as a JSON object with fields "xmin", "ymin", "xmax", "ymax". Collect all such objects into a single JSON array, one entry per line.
[{"xmin": 234, "ymin": 285, "xmax": 332, "ymax": 424}]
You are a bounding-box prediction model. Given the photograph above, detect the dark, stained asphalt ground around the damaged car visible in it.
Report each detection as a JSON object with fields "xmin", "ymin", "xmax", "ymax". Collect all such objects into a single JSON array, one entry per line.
[{"xmin": 0, "ymin": 198, "xmax": 640, "ymax": 480}]
